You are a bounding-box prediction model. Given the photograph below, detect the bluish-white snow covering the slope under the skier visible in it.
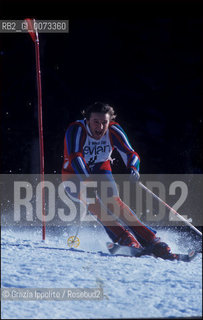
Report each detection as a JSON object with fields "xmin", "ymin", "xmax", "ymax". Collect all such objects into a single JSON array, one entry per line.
[{"xmin": 1, "ymin": 227, "xmax": 202, "ymax": 319}]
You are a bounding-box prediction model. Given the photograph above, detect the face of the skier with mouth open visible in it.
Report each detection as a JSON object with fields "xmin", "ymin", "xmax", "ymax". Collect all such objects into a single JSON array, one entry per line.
[{"xmin": 87, "ymin": 112, "xmax": 110, "ymax": 140}]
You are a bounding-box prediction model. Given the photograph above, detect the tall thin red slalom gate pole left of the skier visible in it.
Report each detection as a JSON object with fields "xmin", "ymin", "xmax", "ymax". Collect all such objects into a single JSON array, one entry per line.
[{"xmin": 25, "ymin": 19, "xmax": 46, "ymax": 240}]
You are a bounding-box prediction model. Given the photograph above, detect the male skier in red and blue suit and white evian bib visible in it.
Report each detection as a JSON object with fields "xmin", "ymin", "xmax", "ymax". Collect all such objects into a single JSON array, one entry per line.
[{"xmin": 62, "ymin": 102, "xmax": 176, "ymax": 258}]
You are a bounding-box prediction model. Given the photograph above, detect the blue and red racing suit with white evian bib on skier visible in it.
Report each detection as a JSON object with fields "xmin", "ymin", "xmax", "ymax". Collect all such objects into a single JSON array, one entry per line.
[{"xmin": 62, "ymin": 119, "xmax": 155, "ymax": 246}]
